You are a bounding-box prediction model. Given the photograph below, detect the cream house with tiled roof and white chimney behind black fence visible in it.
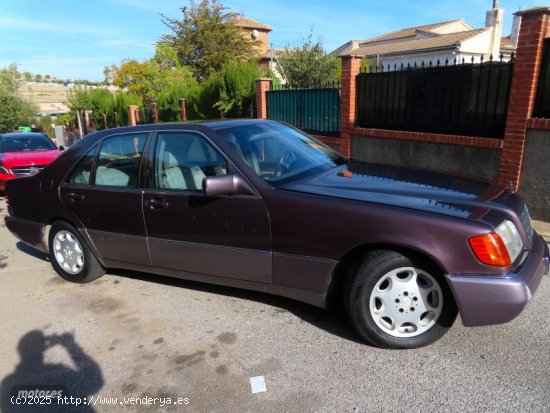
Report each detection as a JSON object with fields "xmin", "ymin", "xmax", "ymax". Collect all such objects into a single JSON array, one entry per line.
[{"xmin": 334, "ymin": 0, "xmax": 521, "ymax": 67}]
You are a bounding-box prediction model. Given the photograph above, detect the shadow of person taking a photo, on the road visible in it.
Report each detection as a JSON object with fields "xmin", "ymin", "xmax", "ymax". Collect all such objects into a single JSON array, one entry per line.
[{"xmin": 0, "ymin": 330, "xmax": 103, "ymax": 413}]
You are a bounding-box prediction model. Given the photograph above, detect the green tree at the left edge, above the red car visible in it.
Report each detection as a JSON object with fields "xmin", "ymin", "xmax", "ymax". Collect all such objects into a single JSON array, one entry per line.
[{"xmin": 0, "ymin": 63, "xmax": 36, "ymax": 131}]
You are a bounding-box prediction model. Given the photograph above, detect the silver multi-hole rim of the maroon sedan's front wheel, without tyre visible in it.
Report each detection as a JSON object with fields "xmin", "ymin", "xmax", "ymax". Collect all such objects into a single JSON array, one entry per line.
[{"xmin": 369, "ymin": 267, "xmax": 443, "ymax": 338}]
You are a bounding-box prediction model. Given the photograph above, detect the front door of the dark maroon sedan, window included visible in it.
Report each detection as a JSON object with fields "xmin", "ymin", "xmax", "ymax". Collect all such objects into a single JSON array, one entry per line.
[{"xmin": 143, "ymin": 131, "xmax": 271, "ymax": 283}]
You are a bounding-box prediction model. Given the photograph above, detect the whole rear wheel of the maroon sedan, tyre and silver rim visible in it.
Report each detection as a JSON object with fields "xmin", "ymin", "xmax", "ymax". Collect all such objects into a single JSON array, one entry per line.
[{"xmin": 48, "ymin": 221, "xmax": 105, "ymax": 283}]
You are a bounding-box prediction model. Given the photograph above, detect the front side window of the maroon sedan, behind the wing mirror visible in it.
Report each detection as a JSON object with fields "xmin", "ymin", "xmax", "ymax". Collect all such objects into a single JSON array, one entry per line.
[{"xmin": 154, "ymin": 132, "xmax": 227, "ymax": 191}]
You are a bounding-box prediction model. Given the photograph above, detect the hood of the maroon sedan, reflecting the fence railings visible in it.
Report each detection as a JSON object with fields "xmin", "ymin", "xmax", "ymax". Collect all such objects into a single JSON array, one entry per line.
[{"xmin": 280, "ymin": 161, "xmax": 519, "ymax": 220}]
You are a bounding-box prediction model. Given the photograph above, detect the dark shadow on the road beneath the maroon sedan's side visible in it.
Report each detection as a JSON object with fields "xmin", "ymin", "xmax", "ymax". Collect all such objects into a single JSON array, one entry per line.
[{"xmin": 116, "ymin": 270, "xmax": 368, "ymax": 345}]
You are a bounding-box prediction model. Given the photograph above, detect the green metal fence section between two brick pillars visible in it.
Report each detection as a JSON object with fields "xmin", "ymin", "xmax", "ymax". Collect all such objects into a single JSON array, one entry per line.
[{"xmin": 267, "ymin": 84, "xmax": 340, "ymax": 136}]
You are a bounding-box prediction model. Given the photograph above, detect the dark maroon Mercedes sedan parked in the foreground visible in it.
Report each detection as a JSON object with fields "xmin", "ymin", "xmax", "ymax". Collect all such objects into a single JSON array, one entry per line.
[{"xmin": 5, "ymin": 120, "xmax": 549, "ymax": 348}]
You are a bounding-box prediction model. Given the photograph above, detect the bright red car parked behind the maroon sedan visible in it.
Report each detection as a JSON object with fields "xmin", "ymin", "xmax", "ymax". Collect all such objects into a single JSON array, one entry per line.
[{"xmin": 0, "ymin": 132, "xmax": 61, "ymax": 191}]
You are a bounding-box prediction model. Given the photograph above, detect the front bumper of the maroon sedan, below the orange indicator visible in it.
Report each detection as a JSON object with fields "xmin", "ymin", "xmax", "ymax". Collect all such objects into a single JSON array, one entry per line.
[{"xmin": 445, "ymin": 234, "xmax": 550, "ymax": 326}]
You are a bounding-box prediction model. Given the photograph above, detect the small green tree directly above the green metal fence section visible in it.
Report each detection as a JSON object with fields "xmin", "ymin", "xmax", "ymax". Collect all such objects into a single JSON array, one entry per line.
[{"xmin": 278, "ymin": 32, "xmax": 339, "ymax": 88}]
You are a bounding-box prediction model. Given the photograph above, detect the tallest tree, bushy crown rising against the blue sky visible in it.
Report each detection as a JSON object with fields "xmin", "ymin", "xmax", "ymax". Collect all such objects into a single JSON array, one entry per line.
[{"xmin": 161, "ymin": 0, "xmax": 258, "ymax": 81}]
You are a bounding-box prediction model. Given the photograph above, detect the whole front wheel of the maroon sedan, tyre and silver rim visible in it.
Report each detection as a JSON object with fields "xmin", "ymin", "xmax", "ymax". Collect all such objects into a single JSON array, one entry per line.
[{"xmin": 344, "ymin": 250, "xmax": 457, "ymax": 349}]
